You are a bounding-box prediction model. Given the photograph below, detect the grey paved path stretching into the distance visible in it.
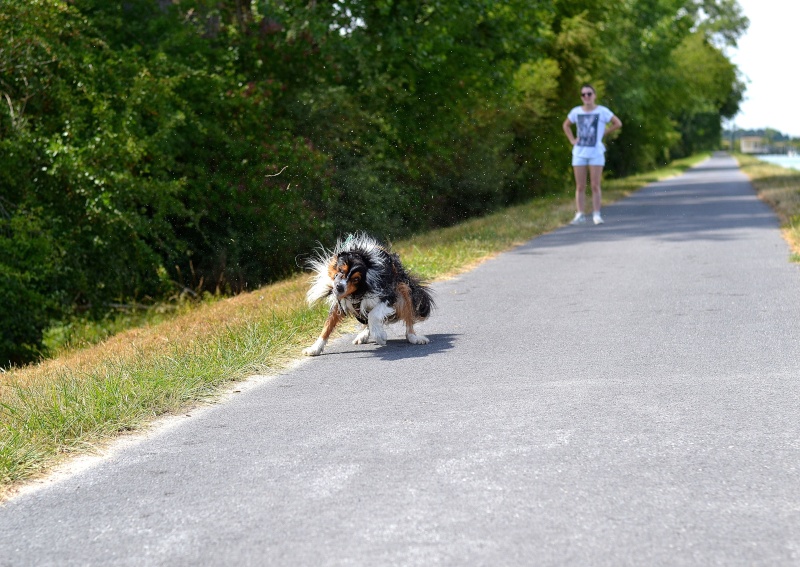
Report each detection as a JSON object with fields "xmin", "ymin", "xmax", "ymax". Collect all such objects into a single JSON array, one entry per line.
[{"xmin": 0, "ymin": 153, "xmax": 800, "ymax": 567}]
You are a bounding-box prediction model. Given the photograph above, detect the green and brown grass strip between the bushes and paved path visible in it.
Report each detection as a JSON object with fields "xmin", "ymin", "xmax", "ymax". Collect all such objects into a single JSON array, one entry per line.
[{"xmin": 0, "ymin": 152, "xmax": 706, "ymax": 500}]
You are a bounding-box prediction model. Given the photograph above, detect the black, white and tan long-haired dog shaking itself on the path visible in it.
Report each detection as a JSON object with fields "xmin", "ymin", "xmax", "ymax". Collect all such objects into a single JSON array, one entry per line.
[{"xmin": 303, "ymin": 233, "xmax": 434, "ymax": 356}]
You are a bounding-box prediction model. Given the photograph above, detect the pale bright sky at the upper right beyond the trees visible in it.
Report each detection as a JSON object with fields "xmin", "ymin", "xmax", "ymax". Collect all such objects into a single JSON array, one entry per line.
[{"xmin": 727, "ymin": 0, "xmax": 800, "ymax": 138}]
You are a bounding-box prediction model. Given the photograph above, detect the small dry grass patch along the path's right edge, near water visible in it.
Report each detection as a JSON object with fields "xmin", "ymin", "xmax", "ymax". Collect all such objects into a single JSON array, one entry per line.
[{"xmin": 736, "ymin": 154, "xmax": 800, "ymax": 262}]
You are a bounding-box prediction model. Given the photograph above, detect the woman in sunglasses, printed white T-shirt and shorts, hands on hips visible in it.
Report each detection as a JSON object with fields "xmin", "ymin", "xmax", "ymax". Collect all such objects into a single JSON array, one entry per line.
[{"xmin": 563, "ymin": 85, "xmax": 622, "ymax": 224}]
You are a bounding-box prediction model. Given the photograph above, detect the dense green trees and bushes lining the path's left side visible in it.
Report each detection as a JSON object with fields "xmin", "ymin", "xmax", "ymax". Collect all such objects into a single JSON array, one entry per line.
[{"xmin": 0, "ymin": 0, "xmax": 747, "ymax": 363}]
